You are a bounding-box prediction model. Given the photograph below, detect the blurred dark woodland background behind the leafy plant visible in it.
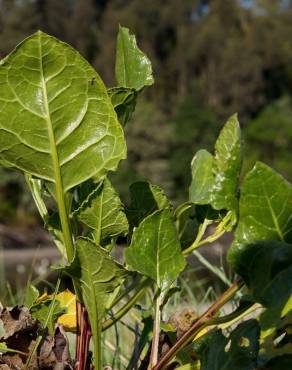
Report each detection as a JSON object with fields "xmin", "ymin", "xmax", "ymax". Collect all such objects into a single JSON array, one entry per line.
[{"xmin": 0, "ymin": 0, "xmax": 292, "ymax": 290}]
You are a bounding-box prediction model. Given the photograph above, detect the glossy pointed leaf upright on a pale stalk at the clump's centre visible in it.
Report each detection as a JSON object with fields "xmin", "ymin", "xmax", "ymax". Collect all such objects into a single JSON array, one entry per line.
[{"xmin": 126, "ymin": 209, "xmax": 185, "ymax": 290}]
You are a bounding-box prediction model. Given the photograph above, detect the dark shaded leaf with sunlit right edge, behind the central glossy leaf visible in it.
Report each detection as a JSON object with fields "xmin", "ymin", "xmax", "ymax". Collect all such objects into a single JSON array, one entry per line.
[{"xmin": 126, "ymin": 181, "xmax": 172, "ymax": 227}]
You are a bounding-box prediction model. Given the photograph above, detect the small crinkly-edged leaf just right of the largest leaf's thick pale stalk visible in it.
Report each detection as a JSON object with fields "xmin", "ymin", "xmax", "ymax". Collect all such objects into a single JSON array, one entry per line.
[{"xmin": 74, "ymin": 179, "xmax": 129, "ymax": 244}]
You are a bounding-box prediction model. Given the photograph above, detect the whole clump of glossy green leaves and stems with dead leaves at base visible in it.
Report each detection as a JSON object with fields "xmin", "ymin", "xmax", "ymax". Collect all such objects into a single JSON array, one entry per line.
[{"xmin": 0, "ymin": 28, "xmax": 292, "ymax": 370}]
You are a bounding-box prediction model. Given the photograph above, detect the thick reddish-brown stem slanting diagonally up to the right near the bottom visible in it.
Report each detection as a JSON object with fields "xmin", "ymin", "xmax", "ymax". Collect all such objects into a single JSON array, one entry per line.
[{"xmin": 152, "ymin": 280, "xmax": 244, "ymax": 370}]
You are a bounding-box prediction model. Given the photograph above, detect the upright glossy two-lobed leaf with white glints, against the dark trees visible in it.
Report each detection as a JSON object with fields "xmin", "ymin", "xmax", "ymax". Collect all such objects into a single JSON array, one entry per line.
[{"xmin": 189, "ymin": 115, "xmax": 242, "ymax": 211}]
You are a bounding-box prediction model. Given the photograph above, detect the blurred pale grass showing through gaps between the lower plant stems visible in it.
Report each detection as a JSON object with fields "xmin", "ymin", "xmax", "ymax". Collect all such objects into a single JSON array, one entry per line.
[{"xmin": 0, "ymin": 244, "xmax": 237, "ymax": 370}]
